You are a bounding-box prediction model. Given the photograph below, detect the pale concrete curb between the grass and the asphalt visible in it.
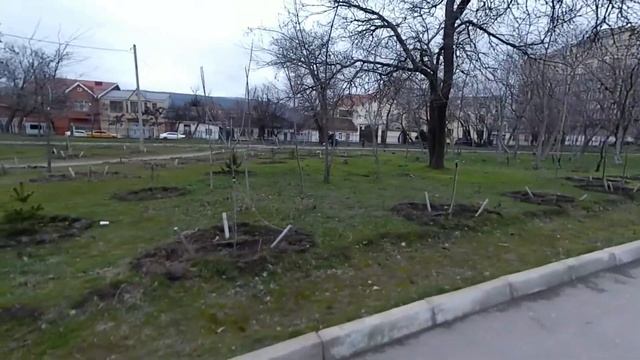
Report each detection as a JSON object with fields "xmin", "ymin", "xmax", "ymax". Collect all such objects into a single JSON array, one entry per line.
[{"xmin": 233, "ymin": 240, "xmax": 640, "ymax": 360}]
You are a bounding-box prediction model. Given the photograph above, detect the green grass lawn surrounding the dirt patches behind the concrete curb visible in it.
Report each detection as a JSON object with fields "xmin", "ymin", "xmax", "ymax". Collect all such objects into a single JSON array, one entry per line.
[{"xmin": 0, "ymin": 151, "xmax": 640, "ymax": 358}]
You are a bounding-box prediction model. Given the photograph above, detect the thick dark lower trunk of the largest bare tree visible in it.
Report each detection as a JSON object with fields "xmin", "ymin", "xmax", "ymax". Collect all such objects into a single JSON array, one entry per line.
[{"xmin": 427, "ymin": 94, "xmax": 448, "ymax": 169}]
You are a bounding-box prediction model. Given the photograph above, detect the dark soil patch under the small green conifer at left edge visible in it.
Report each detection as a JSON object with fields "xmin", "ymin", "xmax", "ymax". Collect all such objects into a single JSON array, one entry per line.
[{"xmin": 0, "ymin": 215, "xmax": 93, "ymax": 248}]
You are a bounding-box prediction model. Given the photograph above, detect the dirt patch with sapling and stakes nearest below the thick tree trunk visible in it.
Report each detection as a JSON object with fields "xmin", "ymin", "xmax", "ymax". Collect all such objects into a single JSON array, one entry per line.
[{"xmin": 391, "ymin": 202, "xmax": 502, "ymax": 225}]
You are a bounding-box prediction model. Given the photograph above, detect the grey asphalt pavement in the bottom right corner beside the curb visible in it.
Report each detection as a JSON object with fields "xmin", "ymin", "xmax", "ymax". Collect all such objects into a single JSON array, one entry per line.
[{"xmin": 354, "ymin": 262, "xmax": 640, "ymax": 360}]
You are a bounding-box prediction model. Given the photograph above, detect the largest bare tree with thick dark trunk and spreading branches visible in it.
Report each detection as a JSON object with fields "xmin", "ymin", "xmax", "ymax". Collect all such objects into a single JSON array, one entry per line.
[{"xmin": 330, "ymin": 0, "xmax": 576, "ymax": 169}]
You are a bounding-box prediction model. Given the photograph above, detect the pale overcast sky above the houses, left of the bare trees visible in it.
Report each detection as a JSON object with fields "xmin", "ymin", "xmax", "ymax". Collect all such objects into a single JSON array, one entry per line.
[{"xmin": 0, "ymin": 0, "xmax": 284, "ymax": 96}]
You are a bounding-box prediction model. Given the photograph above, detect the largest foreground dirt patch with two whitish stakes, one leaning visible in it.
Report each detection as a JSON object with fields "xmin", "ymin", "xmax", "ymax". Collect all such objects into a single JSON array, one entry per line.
[{"xmin": 132, "ymin": 223, "xmax": 314, "ymax": 280}]
